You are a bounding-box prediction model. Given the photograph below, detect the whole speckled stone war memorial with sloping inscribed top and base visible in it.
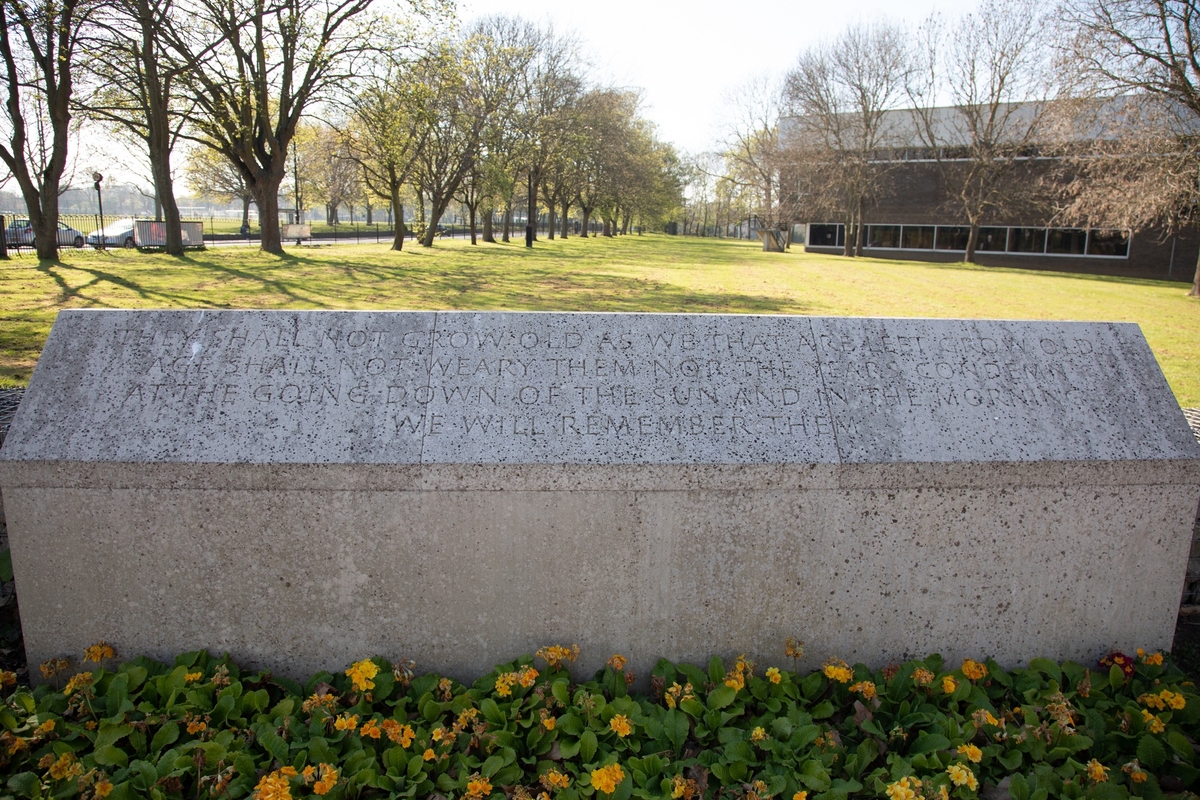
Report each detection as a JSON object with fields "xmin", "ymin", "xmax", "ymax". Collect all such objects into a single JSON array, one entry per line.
[{"xmin": 0, "ymin": 311, "xmax": 1200, "ymax": 679}]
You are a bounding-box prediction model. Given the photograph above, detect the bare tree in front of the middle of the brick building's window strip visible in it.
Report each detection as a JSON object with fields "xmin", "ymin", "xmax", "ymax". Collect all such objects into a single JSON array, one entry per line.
[{"xmin": 907, "ymin": 0, "xmax": 1050, "ymax": 263}]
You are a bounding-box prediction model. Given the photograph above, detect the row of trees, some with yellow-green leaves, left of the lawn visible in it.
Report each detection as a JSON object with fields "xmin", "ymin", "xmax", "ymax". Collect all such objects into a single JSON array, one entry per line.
[{"xmin": 0, "ymin": 0, "xmax": 680, "ymax": 258}]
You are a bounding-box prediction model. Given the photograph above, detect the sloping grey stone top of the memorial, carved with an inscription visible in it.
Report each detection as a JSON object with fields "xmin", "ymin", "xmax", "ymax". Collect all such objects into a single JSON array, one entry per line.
[{"xmin": 0, "ymin": 311, "xmax": 1200, "ymax": 464}]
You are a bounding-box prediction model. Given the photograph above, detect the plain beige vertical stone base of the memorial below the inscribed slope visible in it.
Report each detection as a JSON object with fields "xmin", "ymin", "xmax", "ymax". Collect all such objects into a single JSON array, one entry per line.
[{"xmin": 0, "ymin": 461, "xmax": 1200, "ymax": 679}]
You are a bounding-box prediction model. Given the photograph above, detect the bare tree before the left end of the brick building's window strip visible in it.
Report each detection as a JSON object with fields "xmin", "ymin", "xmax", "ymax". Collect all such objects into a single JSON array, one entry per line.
[{"xmin": 784, "ymin": 23, "xmax": 908, "ymax": 255}]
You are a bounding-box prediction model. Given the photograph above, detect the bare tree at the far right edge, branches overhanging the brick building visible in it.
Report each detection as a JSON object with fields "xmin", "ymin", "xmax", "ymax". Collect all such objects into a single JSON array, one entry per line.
[{"xmin": 1060, "ymin": 0, "xmax": 1200, "ymax": 297}]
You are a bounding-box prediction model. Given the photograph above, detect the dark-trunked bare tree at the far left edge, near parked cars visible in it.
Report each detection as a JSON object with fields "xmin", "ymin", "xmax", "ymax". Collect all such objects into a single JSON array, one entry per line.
[{"xmin": 0, "ymin": 0, "xmax": 95, "ymax": 259}]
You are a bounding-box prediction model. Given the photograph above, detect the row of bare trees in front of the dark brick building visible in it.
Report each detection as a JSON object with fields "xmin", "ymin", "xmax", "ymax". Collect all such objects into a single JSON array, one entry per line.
[{"xmin": 691, "ymin": 0, "xmax": 1200, "ymax": 295}]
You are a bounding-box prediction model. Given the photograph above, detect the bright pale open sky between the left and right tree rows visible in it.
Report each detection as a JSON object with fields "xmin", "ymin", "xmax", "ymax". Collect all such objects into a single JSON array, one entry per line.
[{"xmin": 457, "ymin": 0, "xmax": 977, "ymax": 154}]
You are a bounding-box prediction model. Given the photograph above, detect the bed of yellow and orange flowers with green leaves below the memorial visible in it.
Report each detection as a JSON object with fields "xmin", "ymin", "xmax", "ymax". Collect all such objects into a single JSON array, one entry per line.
[{"xmin": 0, "ymin": 640, "xmax": 1200, "ymax": 800}]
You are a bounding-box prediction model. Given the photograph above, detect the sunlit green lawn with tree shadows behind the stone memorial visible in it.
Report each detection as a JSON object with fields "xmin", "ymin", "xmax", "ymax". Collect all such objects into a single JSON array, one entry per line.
[{"xmin": 0, "ymin": 235, "xmax": 1200, "ymax": 407}]
